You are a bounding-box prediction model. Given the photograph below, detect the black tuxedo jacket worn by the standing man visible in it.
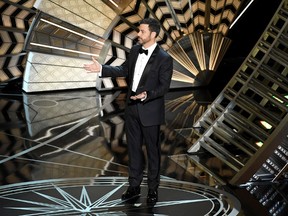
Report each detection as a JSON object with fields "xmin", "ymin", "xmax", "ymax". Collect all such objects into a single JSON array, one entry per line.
[{"xmin": 101, "ymin": 45, "xmax": 173, "ymax": 126}]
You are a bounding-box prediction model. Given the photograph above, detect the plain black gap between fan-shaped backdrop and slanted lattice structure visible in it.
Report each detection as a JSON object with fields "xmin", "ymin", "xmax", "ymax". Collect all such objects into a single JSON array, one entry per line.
[{"xmin": 208, "ymin": 0, "xmax": 282, "ymax": 98}]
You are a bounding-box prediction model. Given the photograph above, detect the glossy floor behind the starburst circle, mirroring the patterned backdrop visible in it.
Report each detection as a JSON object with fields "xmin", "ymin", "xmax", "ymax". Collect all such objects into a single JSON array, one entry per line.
[{"xmin": 0, "ymin": 89, "xmax": 243, "ymax": 214}]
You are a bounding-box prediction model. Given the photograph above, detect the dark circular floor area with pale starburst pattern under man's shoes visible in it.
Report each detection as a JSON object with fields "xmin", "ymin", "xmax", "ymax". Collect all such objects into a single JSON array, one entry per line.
[{"xmin": 0, "ymin": 177, "xmax": 241, "ymax": 216}]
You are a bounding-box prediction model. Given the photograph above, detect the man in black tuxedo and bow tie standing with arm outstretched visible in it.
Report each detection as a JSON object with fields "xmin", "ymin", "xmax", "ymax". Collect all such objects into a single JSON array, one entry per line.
[{"xmin": 84, "ymin": 18, "xmax": 173, "ymax": 204}]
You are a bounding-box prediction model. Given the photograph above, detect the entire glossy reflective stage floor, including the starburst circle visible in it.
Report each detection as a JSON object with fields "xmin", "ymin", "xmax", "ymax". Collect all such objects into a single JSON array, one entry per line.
[{"xmin": 0, "ymin": 89, "xmax": 284, "ymax": 216}]
